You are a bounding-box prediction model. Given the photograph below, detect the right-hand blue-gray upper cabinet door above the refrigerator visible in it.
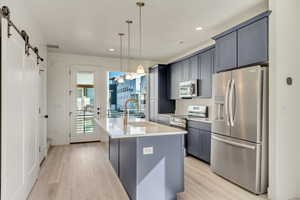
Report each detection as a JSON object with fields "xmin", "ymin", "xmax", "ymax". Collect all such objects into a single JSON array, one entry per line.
[{"xmin": 237, "ymin": 17, "xmax": 268, "ymax": 67}]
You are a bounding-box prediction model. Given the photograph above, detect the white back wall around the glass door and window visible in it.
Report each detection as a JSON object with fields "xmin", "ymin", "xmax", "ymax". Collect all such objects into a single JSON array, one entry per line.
[{"xmin": 48, "ymin": 53, "xmax": 156, "ymax": 145}]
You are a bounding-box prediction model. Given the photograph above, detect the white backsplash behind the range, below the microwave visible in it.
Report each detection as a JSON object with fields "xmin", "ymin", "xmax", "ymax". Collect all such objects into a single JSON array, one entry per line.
[{"xmin": 175, "ymin": 98, "xmax": 212, "ymax": 119}]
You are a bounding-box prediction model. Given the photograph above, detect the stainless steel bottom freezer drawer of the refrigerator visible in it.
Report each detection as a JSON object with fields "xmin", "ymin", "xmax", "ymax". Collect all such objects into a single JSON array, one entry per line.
[{"xmin": 211, "ymin": 134, "xmax": 267, "ymax": 194}]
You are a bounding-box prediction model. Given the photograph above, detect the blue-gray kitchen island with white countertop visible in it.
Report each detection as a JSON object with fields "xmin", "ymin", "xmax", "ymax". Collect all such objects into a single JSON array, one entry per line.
[{"xmin": 96, "ymin": 118, "xmax": 187, "ymax": 200}]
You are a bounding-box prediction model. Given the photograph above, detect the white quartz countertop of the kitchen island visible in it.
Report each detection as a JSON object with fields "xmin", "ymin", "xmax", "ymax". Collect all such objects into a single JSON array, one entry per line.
[{"xmin": 95, "ymin": 118, "xmax": 187, "ymax": 138}]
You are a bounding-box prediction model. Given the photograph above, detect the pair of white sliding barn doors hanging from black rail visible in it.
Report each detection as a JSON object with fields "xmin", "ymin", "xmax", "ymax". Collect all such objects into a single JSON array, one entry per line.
[{"xmin": 1, "ymin": 19, "xmax": 39, "ymax": 200}]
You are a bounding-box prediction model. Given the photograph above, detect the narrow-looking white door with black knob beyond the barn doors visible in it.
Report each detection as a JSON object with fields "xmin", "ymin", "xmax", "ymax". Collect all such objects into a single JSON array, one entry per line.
[{"xmin": 38, "ymin": 67, "xmax": 48, "ymax": 163}]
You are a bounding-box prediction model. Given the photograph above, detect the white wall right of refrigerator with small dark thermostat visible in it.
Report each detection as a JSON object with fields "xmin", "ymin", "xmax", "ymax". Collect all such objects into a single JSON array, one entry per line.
[{"xmin": 269, "ymin": 0, "xmax": 300, "ymax": 200}]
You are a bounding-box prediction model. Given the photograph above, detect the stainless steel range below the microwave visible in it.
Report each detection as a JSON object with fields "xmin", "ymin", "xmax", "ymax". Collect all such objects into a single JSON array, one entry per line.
[{"xmin": 170, "ymin": 106, "xmax": 208, "ymax": 129}]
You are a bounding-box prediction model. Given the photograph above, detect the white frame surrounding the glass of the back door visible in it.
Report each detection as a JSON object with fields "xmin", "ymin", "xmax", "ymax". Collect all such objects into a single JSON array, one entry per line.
[{"xmin": 68, "ymin": 65, "xmax": 100, "ymax": 143}]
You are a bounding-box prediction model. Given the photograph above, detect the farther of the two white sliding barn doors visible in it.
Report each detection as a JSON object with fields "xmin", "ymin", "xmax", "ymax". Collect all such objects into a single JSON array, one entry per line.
[{"xmin": 22, "ymin": 48, "xmax": 39, "ymax": 197}]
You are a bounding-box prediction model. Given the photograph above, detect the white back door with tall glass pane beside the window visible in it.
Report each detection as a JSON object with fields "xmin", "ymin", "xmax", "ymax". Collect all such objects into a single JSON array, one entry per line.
[{"xmin": 70, "ymin": 66, "xmax": 104, "ymax": 143}]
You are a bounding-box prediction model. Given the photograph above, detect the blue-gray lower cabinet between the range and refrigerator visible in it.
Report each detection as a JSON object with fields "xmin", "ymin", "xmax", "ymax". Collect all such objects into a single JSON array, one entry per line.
[{"xmin": 187, "ymin": 121, "xmax": 211, "ymax": 163}]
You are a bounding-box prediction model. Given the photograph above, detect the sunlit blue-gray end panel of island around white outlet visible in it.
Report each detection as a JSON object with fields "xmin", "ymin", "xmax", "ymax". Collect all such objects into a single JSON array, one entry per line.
[{"xmin": 137, "ymin": 135, "xmax": 184, "ymax": 200}]
